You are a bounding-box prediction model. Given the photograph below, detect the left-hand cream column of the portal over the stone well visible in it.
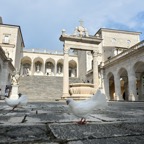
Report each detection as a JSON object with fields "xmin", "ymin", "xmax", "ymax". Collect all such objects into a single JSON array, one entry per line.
[{"xmin": 62, "ymin": 45, "xmax": 69, "ymax": 98}]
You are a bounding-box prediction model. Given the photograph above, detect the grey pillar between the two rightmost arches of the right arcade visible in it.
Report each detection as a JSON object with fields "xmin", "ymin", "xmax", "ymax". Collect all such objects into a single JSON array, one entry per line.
[{"xmin": 128, "ymin": 68, "xmax": 138, "ymax": 101}]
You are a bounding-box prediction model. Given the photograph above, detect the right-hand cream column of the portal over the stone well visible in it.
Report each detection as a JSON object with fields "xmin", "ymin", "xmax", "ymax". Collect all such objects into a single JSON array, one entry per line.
[{"xmin": 93, "ymin": 50, "xmax": 99, "ymax": 89}]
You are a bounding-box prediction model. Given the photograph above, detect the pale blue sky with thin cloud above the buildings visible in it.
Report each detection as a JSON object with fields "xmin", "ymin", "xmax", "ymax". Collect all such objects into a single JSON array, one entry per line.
[{"xmin": 0, "ymin": 0, "xmax": 144, "ymax": 51}]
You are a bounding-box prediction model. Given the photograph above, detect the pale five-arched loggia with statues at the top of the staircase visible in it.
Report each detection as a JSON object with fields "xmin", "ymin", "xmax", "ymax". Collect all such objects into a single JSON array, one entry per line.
[{"xmin": 20, "ymin": 49, "xmax": 78, "ymax": 77}]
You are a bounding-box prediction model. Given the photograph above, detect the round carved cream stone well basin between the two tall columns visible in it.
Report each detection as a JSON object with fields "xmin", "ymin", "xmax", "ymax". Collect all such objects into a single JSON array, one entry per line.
[{"xmin": 69, "ymin": 83, "xmax": 96, "ymax": 99}]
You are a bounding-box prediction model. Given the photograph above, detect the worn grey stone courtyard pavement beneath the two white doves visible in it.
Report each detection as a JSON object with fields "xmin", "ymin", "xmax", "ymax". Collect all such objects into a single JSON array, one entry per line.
[{"xmin": 0, "ymin": 102, "xmax": 144, "ymax": 144}]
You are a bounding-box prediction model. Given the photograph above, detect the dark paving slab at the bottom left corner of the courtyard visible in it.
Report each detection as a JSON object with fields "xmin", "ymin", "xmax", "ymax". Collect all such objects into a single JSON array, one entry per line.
[{"xmin": 0, "ymin": 125, "xmax": 49, "ymax": 143}]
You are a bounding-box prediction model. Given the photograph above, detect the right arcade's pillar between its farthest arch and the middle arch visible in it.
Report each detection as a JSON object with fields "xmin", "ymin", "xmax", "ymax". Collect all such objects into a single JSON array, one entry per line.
[{"xmin": 114, "ymin": 73, "xmax": 123, "ymax": 100}]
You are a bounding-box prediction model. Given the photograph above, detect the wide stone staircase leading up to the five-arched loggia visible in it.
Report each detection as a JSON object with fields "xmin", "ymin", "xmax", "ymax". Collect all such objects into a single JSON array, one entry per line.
[{"xmin": 19, "ymin": 76, "xmax": 80, "ymax": 102}]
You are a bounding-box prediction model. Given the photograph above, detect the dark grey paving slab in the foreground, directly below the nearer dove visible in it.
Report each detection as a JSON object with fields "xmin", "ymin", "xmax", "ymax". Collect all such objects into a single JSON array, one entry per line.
[{"xmin": 50, "ymin": 124, "xmax": 137, "ymax": 140}]
